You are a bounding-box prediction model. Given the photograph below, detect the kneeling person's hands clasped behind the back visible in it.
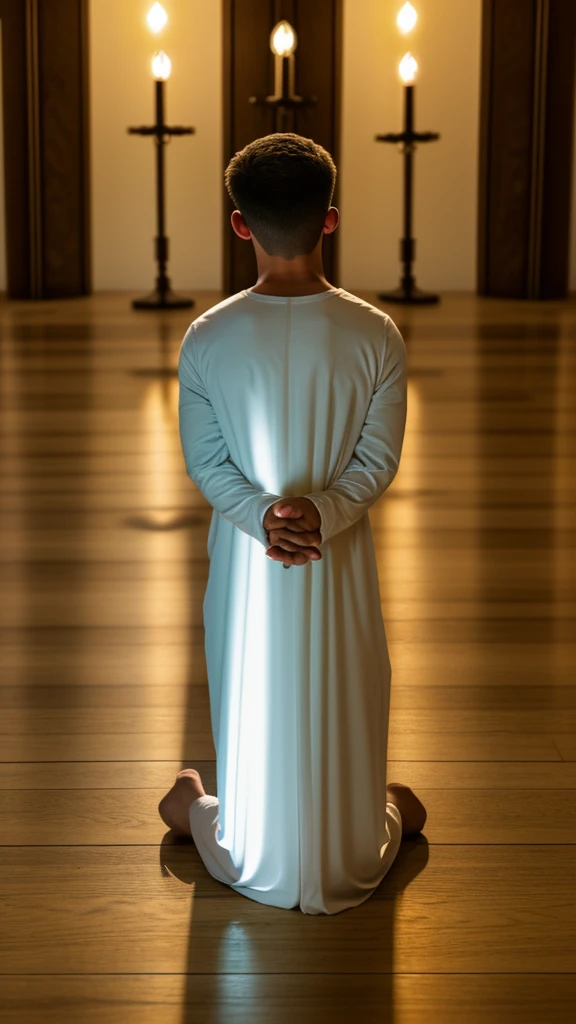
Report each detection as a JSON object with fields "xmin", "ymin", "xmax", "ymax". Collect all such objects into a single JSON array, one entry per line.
[{"xmin": 262, "ymin": 497, "xmax": 322, "ymax": 566}]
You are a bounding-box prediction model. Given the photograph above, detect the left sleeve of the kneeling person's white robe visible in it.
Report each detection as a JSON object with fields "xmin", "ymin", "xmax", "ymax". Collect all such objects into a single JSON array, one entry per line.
[{"xmin": 178, "ymin": 325, "xmax": 282, "ymax": 548}]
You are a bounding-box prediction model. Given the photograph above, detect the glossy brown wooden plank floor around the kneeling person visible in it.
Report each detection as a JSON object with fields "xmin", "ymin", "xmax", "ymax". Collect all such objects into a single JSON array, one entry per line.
[{"xmin": 0, "ymin": 293, "xmax": 576, "ymax": 1024}]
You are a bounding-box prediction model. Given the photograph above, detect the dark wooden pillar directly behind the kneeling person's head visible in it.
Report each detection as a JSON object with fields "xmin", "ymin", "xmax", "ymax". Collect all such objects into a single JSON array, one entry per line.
[{"xmin": 222, "ymin": 0, "xmax": 342, "ymax": 294}]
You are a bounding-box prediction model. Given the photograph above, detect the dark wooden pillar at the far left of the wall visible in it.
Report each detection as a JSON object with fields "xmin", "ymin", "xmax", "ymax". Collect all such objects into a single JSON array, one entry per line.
[{"xmin": 0, "ymin": 0, "xmax": 91, "ymax": 299}]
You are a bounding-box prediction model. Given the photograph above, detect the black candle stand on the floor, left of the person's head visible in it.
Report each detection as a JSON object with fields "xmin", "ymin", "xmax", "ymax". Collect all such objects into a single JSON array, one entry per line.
[{"xmin": 127, "ymin": 80, "xmax": 196, "ymax": 309}]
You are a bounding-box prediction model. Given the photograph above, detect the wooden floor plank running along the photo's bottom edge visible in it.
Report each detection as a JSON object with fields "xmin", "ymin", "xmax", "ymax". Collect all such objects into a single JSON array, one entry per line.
[{"xmin": 0, "ymin": 971, "xmax": 576, "ymax": 1024}]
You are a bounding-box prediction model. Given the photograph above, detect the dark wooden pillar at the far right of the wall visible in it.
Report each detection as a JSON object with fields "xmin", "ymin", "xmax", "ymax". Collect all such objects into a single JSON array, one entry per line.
[{"xmin": 479, "ymin": 0, "xmax": 576, "ymax": 299}]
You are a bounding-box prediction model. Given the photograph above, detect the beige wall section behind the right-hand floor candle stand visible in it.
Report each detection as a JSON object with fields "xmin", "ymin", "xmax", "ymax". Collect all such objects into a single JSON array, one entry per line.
[{"xmin": 340, "ymin": 0, "xmax": 481, "ymax": 290}]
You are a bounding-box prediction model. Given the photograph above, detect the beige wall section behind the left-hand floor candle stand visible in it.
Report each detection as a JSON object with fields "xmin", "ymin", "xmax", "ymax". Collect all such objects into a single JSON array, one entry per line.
[{"xmin": 90, "ymin": 0, "xmax": 222, "ymax": 292}]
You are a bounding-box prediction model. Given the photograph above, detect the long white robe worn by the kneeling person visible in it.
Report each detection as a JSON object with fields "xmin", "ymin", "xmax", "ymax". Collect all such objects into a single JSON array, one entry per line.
[{"xmin": 178, "ymin": 288, "xmax": 406, "ymax": 913}]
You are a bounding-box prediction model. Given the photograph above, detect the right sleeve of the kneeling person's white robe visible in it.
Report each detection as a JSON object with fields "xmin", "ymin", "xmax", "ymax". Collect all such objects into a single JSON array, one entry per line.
[{"xmin": 304, "ymin": 317, "xmax": 407, "ymax": 544}]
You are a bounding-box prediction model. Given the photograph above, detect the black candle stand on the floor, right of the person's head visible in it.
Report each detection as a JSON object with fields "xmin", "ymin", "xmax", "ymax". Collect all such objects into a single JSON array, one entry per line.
[{"xmin": 374, "ymin": 85, "xmax": 440, "ymax": 305}]
